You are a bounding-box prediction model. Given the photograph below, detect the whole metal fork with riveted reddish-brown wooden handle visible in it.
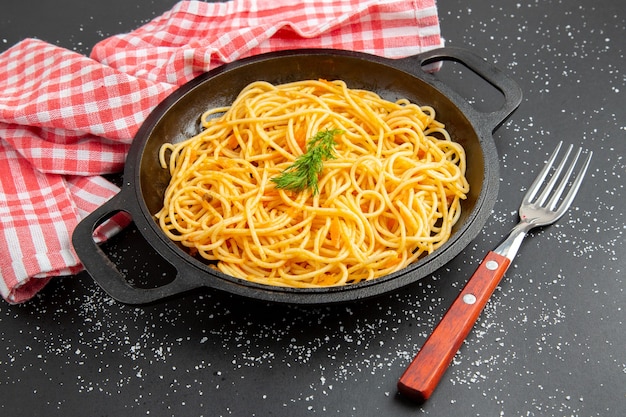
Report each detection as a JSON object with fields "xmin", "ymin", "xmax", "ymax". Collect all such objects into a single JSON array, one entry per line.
[{"xmin": 398, "ymin": 142, "xmax": 592, "ymax": 402}]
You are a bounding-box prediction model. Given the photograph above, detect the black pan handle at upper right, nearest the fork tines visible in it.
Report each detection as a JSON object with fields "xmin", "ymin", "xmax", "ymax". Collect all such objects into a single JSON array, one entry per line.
[{"xmin": 417, "ymin": 47, "xmax": 522, "ymax": 132}]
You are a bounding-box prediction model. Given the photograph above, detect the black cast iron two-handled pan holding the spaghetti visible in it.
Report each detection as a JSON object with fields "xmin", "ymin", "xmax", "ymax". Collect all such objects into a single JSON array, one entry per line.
[{"xmin": 73, "ymin": 48, "xmax": 522, "ymax": 304}]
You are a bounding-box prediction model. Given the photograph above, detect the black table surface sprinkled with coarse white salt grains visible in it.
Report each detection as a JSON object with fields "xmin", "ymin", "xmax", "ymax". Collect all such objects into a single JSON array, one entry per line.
[{"xmin": 0, "ymin": 0, "xmax": 626, "ymax": 417}]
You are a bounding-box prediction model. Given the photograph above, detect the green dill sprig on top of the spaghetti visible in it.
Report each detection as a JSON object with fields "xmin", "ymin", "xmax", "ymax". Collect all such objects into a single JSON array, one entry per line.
[{"xmin": 271, "ymin": 129, "xmax": 343, "ymax": 195}]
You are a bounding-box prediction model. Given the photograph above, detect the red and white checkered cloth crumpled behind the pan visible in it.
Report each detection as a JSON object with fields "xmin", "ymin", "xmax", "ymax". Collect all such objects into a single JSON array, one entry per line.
[{"xmin": 0, "ymin": 0, "xmax": 443, "ymax": 303}]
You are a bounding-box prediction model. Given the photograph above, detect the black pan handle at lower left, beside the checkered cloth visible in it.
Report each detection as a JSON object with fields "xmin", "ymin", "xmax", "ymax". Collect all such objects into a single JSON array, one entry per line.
[{"xmin": 72, "ymin": 192, "xmax": 201, "ymax": 304}]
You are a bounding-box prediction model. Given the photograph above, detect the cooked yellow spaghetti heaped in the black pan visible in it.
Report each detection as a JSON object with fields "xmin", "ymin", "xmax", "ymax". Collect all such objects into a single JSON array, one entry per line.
[{"xmin": 156, "ymin": 80, "xmax": 469, "ymax": 287}]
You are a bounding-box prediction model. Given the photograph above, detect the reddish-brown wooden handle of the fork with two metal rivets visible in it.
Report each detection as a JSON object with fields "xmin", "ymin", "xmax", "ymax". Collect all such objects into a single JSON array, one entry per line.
[{"xmin": 398, "ymin": 251, "xmax": 511, "ymax": 401}]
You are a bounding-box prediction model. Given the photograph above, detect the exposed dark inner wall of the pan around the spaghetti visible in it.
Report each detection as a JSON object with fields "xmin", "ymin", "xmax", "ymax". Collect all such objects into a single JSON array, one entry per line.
[{"xmin": 140, "ymin": 54, "xmax": 485, "ymax": 270}]
